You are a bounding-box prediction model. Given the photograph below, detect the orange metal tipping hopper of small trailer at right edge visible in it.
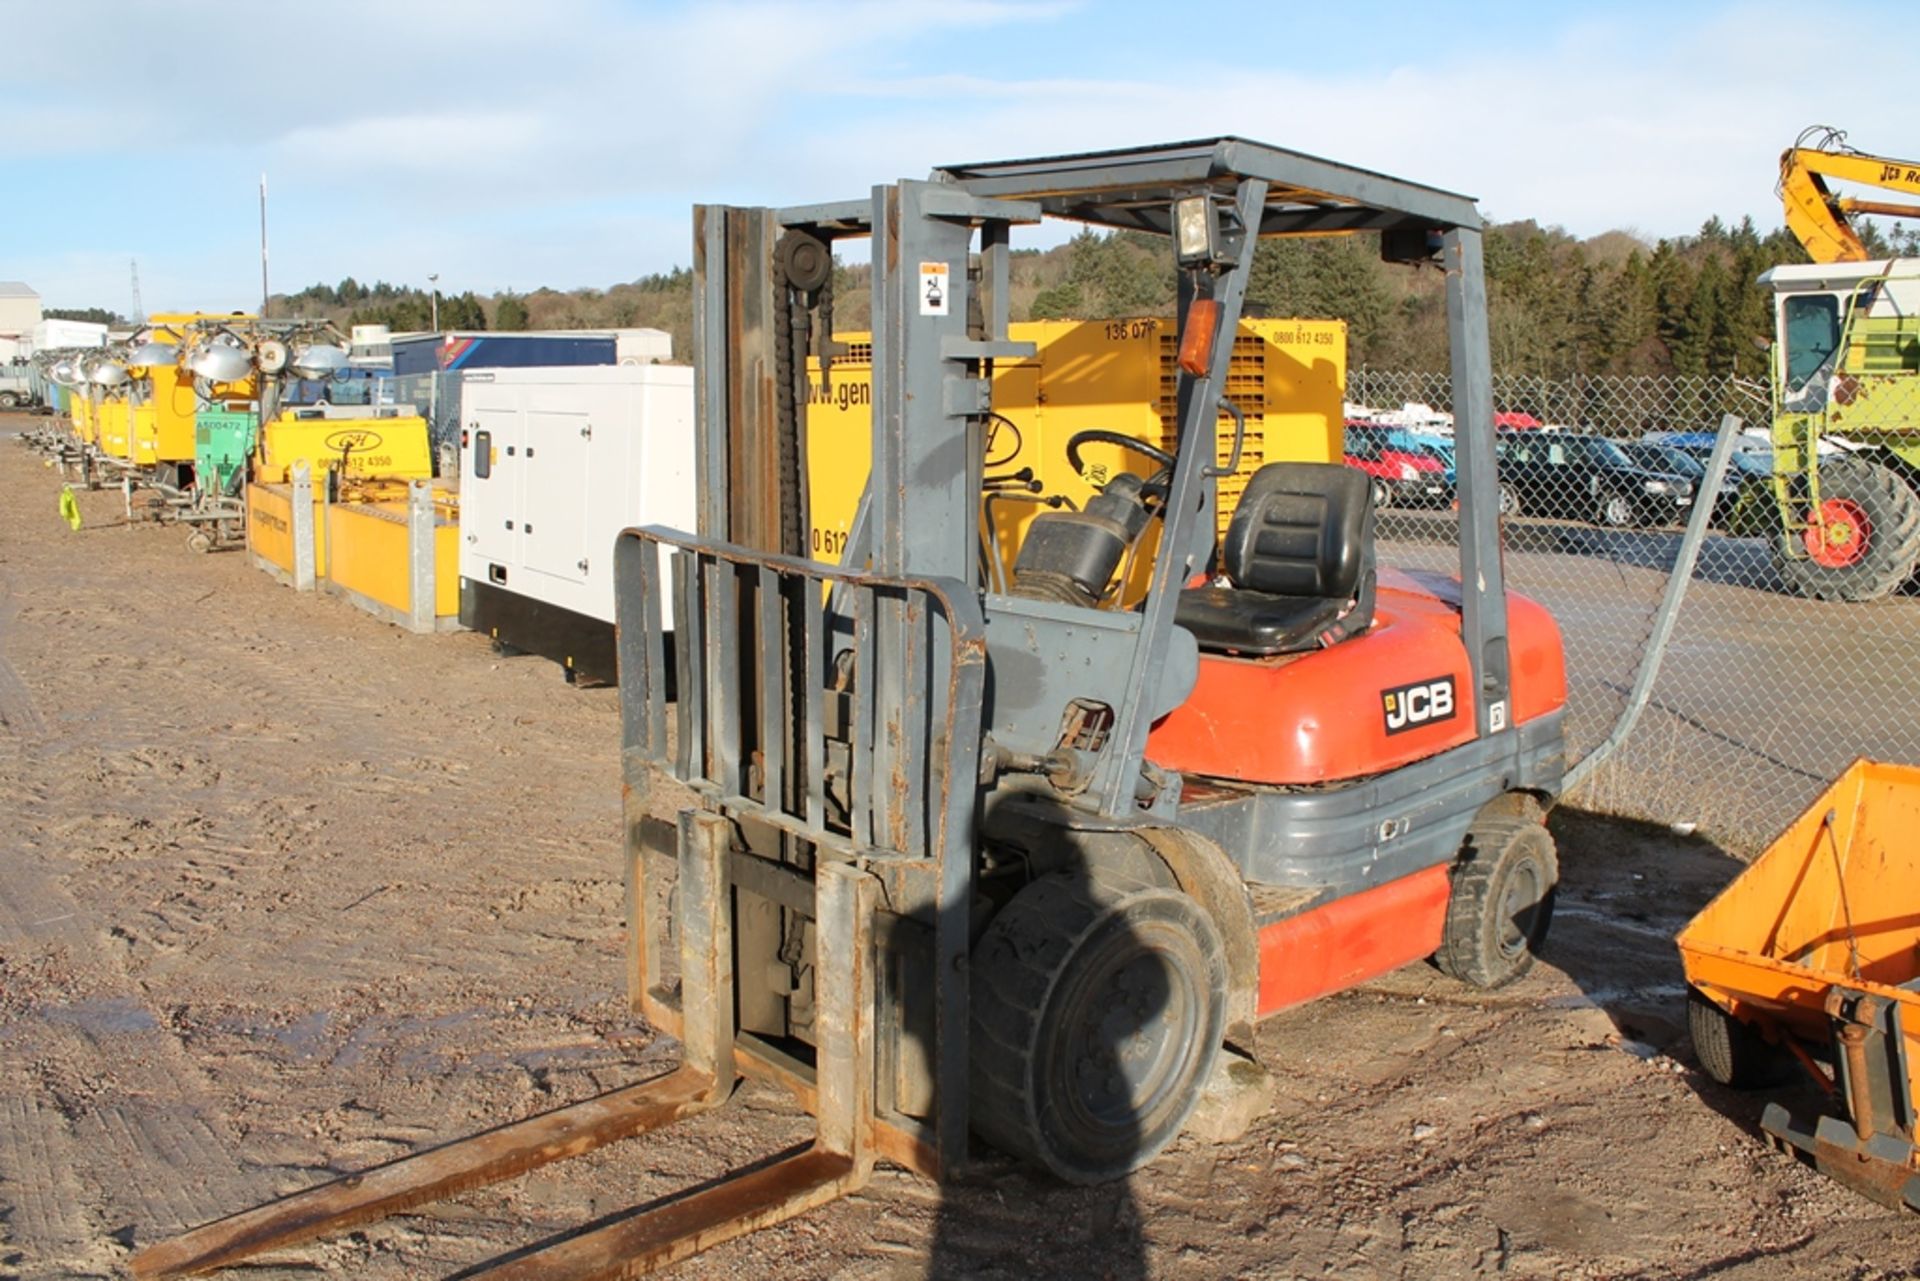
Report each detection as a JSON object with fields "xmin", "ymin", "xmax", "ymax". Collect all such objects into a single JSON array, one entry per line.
[{"xmin": 1678, "ymin": 761, "xmax": 1920, "ymax": 1060}]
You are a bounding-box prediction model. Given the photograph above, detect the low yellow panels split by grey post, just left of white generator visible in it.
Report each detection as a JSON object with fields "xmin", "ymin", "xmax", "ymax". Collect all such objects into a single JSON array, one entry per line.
[{"xmin": 324, "ymin": 486, "xmax": 461, "ymax": 630}]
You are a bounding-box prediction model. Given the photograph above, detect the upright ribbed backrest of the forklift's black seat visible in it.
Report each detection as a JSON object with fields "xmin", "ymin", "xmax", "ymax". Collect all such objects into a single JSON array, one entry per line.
[{"xmin": 1221, "ymin": 463, "xmax": 1373, "ymax": 599}]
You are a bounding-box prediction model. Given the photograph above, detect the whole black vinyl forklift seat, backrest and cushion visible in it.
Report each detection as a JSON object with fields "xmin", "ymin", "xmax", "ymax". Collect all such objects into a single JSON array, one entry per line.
[{"xmin": 1173, "ymin": 463, "xmax": 1375, "ymax": 657}]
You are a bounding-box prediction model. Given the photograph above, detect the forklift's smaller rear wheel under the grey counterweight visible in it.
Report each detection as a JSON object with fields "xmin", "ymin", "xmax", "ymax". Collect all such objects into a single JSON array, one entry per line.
[{"xmin": 1434, "ymin": 816, "xmax": 1559, "ymax": 987}]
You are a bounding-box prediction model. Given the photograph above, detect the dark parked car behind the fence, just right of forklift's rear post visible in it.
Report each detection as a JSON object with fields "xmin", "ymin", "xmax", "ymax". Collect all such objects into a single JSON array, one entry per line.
[{"xmin": 1494, "ymin": 432, "xmax": 1693, "ymax": 528}]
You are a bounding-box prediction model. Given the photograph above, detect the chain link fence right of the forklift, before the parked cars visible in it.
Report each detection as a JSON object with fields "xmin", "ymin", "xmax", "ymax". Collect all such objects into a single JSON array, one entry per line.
[{"xmin": 1348, "ymin": 369, "xmax": 1920, "ymax": 851}]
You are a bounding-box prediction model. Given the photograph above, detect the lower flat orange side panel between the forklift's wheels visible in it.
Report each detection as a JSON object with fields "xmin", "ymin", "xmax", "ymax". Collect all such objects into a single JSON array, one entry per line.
[{"xmin": 1260, "ymin": 864, "xmax": 1452, "ymax": 1016}]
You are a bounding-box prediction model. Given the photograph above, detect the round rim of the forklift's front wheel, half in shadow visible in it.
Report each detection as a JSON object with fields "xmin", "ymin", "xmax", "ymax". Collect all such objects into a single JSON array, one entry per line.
[{"xmin": 1046, "ymin": 922, "xmax": 1206, "ymax": 1154}]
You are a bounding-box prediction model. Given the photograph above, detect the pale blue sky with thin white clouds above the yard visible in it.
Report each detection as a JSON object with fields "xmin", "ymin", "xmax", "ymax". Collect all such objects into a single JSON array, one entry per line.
[{"xmin": 0, "ymin": 0, "xmax": 1920, "ymax": 313}]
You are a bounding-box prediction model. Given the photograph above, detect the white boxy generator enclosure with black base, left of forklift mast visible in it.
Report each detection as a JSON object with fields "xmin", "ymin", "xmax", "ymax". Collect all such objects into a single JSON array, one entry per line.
[{"xmin": 461, "ymin": 365, "xmax": 697, "ymax": 684}]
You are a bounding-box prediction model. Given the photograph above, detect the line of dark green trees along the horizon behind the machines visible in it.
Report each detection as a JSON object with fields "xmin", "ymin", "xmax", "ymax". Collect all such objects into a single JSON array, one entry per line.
[{"xmin": 251, "ymin": 217, "xmax": 1920, "ymax": 378}]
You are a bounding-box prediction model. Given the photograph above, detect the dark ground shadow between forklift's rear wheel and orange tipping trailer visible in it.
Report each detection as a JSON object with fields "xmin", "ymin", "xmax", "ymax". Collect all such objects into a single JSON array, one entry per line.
[{"xmin": 1542, "ymin": 807, "xmax": 1820, "ymax": 1141}]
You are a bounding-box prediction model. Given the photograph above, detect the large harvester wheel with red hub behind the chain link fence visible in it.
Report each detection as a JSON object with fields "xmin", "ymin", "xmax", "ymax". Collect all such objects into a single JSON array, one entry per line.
[{"xmin": 1776, "ymin": 459, "xmax": 1920, "ymax": 601}]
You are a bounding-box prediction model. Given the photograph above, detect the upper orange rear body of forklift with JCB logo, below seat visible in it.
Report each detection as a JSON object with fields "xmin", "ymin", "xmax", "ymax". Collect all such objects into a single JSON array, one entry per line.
[{"xmin": 1146, "ymin": 572, "xmax": 1567, "ymax": 784}]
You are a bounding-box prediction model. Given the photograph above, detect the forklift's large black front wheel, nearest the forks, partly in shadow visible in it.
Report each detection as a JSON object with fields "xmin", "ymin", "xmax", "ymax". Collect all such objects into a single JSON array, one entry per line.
[{"xmin": 970, "ymin": 874, "xmax": 1227, "ymax": 1183}]
